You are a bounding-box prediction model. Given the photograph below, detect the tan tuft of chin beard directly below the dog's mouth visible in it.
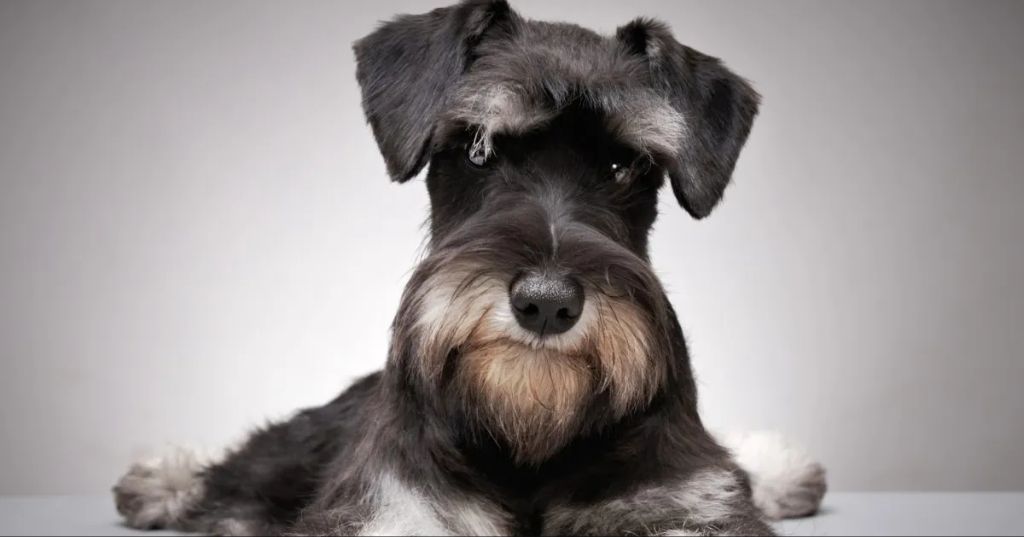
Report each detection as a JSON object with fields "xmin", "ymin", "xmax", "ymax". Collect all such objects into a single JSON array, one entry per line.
[{"xmin": 459, "ymin": 338, "xmax": 598, "ymax": 463}]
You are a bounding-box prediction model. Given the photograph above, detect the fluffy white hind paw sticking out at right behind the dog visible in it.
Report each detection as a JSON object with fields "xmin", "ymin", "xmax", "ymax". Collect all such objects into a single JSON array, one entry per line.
[{"xmin": 723, "ymin": 432, "xmax": 827, "ymax": 520}]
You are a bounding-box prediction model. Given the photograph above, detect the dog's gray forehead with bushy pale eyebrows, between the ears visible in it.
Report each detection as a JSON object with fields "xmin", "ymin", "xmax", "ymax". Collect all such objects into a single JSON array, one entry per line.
[{"xmin": 443, "ymin": 20, "xmax": 686, "ymax": 160}]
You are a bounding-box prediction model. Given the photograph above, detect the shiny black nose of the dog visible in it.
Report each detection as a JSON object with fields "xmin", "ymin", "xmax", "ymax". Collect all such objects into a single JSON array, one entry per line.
[{"xmin": 509, "ymin": 274, "xmax": 583, "ymax": 336}]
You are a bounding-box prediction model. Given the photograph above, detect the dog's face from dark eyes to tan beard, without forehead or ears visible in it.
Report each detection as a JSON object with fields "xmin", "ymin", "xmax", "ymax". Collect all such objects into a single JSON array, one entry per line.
[{"xmin": 411, "ymin": 110, "xmax": 667, "ymax": 458}]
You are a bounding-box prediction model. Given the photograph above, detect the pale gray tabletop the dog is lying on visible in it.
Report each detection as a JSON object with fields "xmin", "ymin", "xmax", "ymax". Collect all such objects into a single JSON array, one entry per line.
[{"xmin": 0, "ymin": 492, "xmax": 1024, "ymax": 536}]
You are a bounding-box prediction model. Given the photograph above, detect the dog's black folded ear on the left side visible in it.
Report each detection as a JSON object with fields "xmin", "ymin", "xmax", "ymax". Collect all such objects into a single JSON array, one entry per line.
[{"xmin": 352, "ymin": 0, "xmax": 509, "ymax": 182}]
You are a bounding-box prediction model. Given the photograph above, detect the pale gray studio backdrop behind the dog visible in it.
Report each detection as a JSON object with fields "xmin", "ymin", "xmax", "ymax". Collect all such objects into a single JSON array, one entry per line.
[{"xmin": 0, "ymin": 0, "xmax": 1024, "ymax": 493}]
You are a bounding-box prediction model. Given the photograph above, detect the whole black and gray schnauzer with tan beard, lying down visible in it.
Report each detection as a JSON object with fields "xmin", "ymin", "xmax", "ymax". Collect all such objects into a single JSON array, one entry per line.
[{"xmin": 114, "ymin": 0, "xmax": 825, "ymax": 535}]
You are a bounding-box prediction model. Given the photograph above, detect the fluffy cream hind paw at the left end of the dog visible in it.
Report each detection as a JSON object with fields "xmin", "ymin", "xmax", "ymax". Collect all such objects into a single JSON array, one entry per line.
[{"xmin": 114, "ymin": 450, "xmax": 204, "ymax": 530}]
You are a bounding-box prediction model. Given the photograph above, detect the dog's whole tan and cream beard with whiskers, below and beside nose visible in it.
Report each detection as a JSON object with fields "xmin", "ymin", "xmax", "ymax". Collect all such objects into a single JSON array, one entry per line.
[{"xmin": 410, "ymin": 264, "xmax": 665, "ymax": 463}]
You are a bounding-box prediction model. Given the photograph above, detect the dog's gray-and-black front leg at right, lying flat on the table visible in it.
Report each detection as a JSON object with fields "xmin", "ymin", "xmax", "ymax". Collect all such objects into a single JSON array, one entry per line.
[{"xmin": 544, "ymin": 468, "xmax": 774, "ymax": 535}]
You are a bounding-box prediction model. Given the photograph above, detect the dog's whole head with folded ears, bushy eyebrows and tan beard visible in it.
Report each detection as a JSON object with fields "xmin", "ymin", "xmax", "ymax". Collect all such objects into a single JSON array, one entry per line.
[{"xmin": 355, "ymin": 1, "xmax": 758, "ymax": 462}]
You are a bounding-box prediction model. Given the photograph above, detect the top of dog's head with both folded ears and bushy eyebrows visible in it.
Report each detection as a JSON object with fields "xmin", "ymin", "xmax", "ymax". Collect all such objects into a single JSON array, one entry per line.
[{"xmin": 355, "ymin": 0, "xmax": 760, "ymax": 218}]
